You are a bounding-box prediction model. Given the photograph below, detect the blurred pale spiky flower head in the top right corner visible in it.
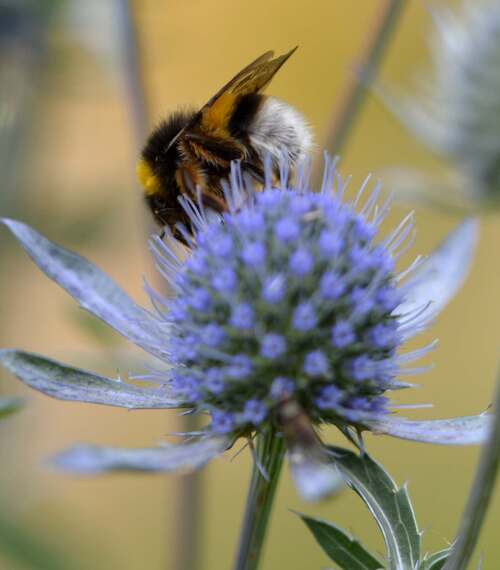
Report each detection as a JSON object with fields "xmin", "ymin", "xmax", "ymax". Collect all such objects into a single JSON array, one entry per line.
[{"xmin": 389, "ymin": 0, "xmax": 500, "ymax": 202}]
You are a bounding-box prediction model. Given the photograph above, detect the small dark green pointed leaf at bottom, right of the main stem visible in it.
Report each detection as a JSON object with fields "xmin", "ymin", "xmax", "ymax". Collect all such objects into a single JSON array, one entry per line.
[{"xmin": 297, "ymin": 513, "xmax": 384, "ymax": 570}]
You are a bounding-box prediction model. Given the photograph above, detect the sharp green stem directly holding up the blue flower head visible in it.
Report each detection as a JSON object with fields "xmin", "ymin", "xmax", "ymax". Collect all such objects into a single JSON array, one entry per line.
[{"xmin": 234, "ymin": 426, "xmax": 285, "ymax": 570}]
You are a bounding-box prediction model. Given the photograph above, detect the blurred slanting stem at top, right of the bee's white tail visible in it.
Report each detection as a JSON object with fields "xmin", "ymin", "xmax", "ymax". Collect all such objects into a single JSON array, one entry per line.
[{"xmin": 325, "ymin": 0, "xmax": 407, "ymax": 156}]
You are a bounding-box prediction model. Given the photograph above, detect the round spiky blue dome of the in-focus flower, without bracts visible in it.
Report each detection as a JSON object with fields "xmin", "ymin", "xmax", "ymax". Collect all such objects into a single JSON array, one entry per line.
[{"xmin": 155, "ymin": 160, "xmax": 421, "ymax": 434}]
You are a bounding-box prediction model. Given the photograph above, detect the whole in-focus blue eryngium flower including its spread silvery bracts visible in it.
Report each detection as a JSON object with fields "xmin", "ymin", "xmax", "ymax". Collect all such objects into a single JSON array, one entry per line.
[{"xmin": 0, "ymin": 155, "xmax": 490, "ymax": 499}]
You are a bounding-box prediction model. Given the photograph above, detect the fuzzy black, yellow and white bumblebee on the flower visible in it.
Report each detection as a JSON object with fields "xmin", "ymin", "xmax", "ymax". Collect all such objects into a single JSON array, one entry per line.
[{"xmin": 137, "ymin": 48, "xmax": 312, "ymax": 241}]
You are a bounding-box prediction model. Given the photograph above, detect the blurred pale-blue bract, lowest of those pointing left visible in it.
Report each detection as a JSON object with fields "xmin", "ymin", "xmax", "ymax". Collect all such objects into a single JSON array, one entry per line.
[{"xmin": 53, "ymin": 437, "xmax": 229, "ymax": 475}]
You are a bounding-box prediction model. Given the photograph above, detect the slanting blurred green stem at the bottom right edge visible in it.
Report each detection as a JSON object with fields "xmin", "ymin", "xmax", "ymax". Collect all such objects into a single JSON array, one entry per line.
[{"xmin": 443, "ymin": 375, "xmax": 500, "ymax": 570}]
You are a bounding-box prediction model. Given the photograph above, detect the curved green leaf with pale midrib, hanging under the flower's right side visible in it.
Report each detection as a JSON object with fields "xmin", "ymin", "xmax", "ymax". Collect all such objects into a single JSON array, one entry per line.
[{"xmin": 329, "ymin": 447, "xmax": 420, "ymax": 570}]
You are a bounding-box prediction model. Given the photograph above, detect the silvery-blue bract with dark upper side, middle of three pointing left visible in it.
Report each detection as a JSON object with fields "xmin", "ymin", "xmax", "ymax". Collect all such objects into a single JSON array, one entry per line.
[{"xmin": 0, "ymin": 350, "xmax": 183, "ymax": 409}]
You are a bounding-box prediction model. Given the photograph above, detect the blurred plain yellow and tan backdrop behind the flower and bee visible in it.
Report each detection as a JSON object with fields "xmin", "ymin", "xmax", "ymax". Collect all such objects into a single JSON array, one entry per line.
[{"xmin": 0, "ymin": 0, "xmax": 500, "ymax": 570}]
